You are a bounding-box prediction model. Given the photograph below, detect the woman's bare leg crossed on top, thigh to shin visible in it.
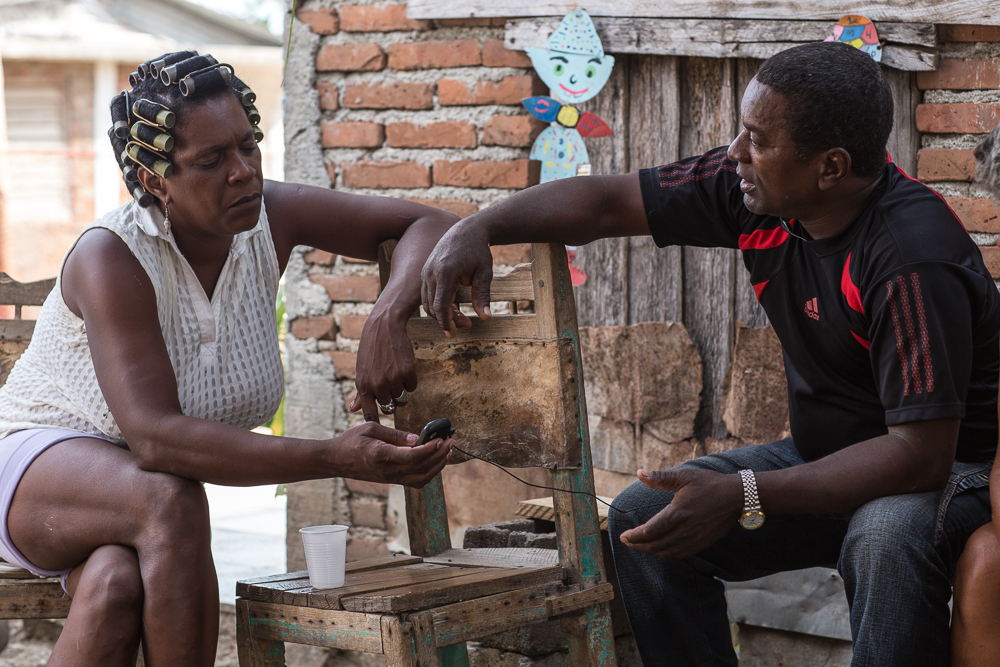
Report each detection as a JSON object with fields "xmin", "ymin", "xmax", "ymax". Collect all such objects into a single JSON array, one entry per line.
[{"xmin": 7, "ymin": 438, "xmax": 219, "ymax": 667}]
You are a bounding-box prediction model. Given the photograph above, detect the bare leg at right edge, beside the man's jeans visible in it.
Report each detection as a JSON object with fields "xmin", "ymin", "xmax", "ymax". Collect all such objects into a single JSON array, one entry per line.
[{"xmin": 951, "ymin": 523, "xmax": 1000, "ymax": 667}]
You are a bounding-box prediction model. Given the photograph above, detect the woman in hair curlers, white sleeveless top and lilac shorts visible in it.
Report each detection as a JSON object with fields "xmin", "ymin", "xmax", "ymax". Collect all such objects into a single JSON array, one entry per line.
[{"xmin": 0, "ymin": 52, "xmax": 456, "ymax": 667}]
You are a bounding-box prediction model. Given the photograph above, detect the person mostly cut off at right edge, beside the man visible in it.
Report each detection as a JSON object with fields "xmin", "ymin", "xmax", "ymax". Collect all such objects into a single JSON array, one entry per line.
[{"xmin": 951, "ymin": 125, "xmax": 1000, "ymax": 667}]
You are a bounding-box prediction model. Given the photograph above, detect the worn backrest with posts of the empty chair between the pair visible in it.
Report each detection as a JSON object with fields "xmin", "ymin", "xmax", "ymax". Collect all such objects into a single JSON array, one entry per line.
[{"xmin": 379, "ymin": 241, "xmax": 605, "ymax": 586}]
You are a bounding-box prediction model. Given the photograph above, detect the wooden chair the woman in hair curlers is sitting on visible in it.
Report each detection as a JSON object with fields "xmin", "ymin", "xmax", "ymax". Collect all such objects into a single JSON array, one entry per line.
[{"xmin": 0, "ymin": 273, "xmax": 70, "ymax": 619}]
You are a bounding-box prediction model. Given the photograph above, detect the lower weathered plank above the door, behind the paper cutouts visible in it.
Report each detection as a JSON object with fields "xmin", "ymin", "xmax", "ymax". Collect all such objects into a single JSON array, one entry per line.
[{"xmin": 504, "ymin": 17, "xmax": 937, "ymax": 72}]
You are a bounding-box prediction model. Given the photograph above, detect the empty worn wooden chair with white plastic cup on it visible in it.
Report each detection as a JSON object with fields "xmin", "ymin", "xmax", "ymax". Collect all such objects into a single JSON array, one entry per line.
[{"xmin": 236, "ymin": 242, "xmax": 616, "ymax": 667}]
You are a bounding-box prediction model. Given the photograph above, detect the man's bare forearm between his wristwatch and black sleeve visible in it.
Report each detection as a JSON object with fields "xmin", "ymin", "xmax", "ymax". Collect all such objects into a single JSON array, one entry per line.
[{"xmin": 756, "ymin": 420, "xmax": 958, "ymax": 514}]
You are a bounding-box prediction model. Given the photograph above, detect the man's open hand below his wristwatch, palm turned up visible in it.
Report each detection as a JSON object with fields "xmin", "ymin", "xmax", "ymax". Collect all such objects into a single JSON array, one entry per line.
[{"xmin": 621, "ymin": 469, "xmax": 743, "ymax": 558}]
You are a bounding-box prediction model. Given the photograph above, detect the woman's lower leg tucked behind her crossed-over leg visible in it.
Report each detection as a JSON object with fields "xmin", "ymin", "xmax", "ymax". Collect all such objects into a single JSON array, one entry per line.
[{"xmin": 48, "ymin": 544, "xmax": 143, "ymax": 667}]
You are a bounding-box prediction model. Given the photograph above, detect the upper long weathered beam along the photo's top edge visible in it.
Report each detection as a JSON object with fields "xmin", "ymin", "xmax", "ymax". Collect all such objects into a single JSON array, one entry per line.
[{"xmin": 406, "ymin": 0, "xmax": 1000, "ymax": 25}]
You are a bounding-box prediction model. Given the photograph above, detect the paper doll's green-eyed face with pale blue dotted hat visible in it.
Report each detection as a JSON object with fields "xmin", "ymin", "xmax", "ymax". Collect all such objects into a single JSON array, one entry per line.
[{"xmin": 525, "ymin": 9, "xmax": 615, "ymax": 102}]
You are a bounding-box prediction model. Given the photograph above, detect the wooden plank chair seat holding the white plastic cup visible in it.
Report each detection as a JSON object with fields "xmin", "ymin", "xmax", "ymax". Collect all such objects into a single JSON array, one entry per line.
[{"xmin": 236, "ymin": 549, "xmax": 563, "ymax": 613}]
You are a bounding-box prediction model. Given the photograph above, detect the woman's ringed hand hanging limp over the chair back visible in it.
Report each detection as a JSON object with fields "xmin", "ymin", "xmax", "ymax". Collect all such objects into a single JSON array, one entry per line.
[{"xmin": 350, "ymin": 305, "xmax": 417, "ymax": 422}]
